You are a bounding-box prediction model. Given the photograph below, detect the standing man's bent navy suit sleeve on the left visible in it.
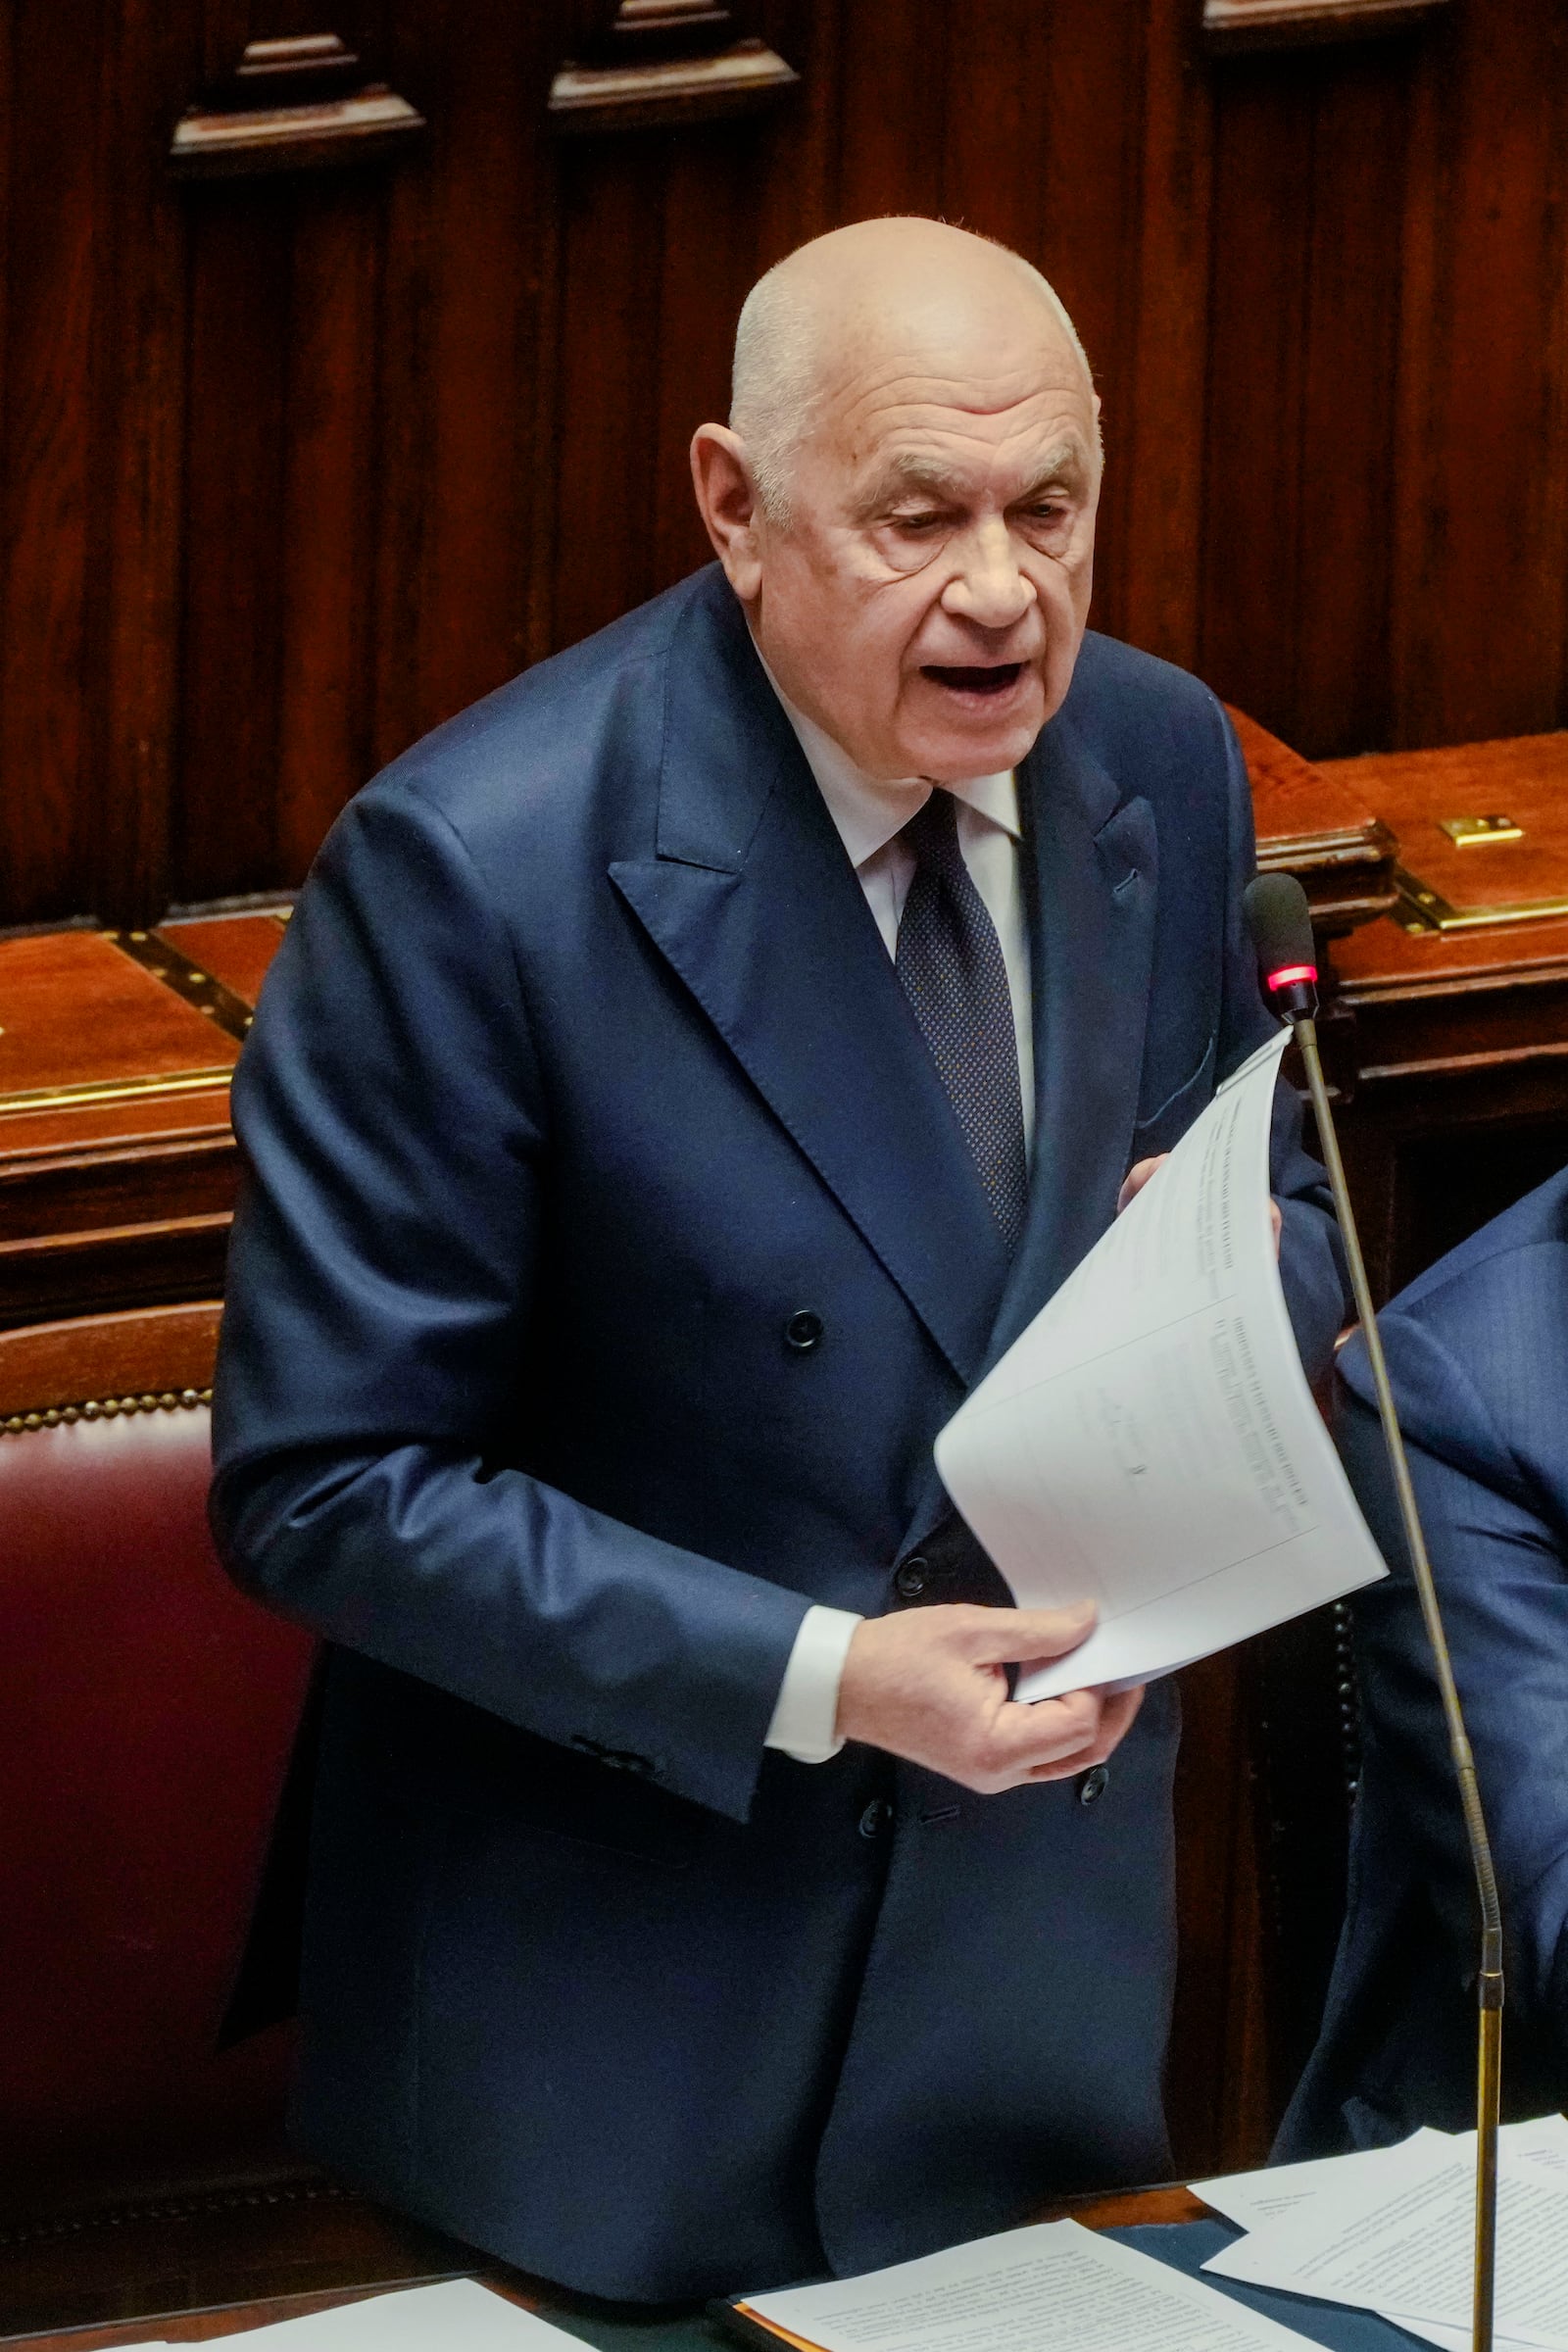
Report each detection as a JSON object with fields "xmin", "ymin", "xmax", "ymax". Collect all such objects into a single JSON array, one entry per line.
[{"xmin": 214, "ymin": 781, "xmax": 808, "ymax": 1818}]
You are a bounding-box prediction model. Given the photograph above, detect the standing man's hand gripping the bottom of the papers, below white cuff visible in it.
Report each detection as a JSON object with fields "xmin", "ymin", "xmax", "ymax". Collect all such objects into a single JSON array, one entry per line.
[{"xmin": 837, "ymin": 1601, "xmax": 1143, "ymax": 1797}]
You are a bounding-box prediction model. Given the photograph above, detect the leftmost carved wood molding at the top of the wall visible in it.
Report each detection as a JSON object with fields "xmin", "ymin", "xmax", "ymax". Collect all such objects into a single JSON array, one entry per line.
[{"xmin": 170, "ymin": 33, "xmax": 425, "ymax": 178}]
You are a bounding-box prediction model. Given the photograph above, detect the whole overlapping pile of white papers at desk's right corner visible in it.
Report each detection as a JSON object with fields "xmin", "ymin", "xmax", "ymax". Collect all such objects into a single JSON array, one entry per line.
[{"xmin": 1195, "ymin": 2115, "xmax": 1568, "ymax": 2352}]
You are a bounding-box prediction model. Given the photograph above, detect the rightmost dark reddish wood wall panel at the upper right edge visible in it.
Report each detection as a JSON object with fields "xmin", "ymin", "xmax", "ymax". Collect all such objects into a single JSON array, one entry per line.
[{"xmin": 1392, "ymin": 5, "xmax": 1568, "ymax": 748}]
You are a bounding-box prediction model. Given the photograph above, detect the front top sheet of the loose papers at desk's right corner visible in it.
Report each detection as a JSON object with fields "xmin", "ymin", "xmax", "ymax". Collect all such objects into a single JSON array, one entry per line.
[{"xmin": 1203, "ymin": 2133, "xmax": 1568, "ymax": 2347}]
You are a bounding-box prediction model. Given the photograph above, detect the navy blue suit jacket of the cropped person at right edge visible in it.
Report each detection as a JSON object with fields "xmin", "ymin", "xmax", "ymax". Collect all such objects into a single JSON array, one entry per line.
[{"xmin": 1277, "ymin": 1174, "xmax": 1568, "ymax": 2157}]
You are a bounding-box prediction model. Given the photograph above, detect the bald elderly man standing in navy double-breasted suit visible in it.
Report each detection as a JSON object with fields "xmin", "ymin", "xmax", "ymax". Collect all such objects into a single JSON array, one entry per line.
[{"xmin": 214, "ymin": 221, "xmax": 1343, "ymax": 2298}]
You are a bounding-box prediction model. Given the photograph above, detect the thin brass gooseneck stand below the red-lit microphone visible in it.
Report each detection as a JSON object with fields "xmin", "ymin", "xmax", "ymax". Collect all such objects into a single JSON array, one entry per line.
[{"xmin": 1284, "ymin": 1009, "xmax": 1502, "ymax": 2352}]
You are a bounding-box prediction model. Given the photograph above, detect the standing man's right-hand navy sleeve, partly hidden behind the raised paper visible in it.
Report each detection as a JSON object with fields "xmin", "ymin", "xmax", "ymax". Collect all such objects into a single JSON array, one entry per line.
[{"xmin": 1218, "ymin": 696, "xmax": 1349, "ymax": 1381}]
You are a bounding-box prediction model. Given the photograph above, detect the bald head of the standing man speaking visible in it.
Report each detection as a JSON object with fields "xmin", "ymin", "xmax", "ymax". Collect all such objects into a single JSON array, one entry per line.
[{"xmin": 691, "ymin": 219, "xmax": 1101, "ymax": 781}]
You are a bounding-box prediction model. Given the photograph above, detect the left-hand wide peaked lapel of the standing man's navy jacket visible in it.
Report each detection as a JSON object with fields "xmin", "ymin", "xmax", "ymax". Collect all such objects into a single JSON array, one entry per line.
[{"xmin": 612, "ymin": 574, "xmax": 1006, "ymax": 1381}]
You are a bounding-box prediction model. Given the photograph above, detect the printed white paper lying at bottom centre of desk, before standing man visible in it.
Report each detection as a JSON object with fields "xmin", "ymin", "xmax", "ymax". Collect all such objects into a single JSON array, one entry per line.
[{"xmin": 745, "ymin": 2221, "xmax": 1307, "ymax": 2352}]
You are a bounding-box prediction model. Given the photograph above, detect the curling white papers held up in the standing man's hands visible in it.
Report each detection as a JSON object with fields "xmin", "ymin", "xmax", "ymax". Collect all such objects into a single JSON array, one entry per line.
[{"xmin": 936, "ymin": 1030, "xmax": 1387, "ymax": 1698}]
